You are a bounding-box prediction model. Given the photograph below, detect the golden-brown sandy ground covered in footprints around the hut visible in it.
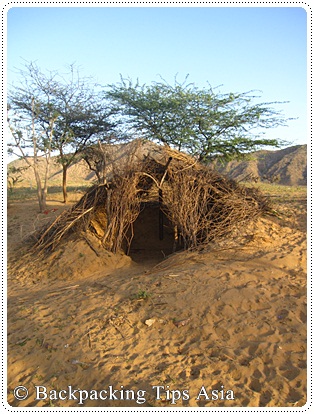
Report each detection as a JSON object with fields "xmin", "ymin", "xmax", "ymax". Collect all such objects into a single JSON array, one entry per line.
[{"xmin": 8, "ymin": 189, "xmax": 307, "ymax": 408}]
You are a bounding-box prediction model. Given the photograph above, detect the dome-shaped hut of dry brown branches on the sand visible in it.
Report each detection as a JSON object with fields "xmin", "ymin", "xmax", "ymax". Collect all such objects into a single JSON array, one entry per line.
[{"xmin": 35, "ymin": 148, "xmax": 269, "ymax": 253}]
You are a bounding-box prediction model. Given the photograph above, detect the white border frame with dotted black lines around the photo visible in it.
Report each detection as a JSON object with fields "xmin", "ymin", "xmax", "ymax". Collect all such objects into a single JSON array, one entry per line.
[{"xmin": 0, "ymin": 0, "xmax": 314, "ymax": 413}]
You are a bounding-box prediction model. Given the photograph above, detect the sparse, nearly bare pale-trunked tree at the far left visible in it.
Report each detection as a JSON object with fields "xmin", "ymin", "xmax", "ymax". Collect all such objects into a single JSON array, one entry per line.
[{"xmin": 7, "ymin": 64, "xmax": 59, "ymax": 212}]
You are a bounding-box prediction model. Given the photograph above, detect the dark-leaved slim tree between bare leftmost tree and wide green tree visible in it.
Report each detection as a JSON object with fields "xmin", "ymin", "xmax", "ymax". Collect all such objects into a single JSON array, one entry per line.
[{"xmin": 53, "ymin": 65, "xmax": 116, "ymax": 203}]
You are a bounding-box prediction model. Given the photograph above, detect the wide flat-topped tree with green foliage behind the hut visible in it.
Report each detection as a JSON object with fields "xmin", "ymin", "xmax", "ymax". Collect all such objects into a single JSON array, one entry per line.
[{"xmin": 106, "ymin": 78, "xmax": 287, "ymax": 162}]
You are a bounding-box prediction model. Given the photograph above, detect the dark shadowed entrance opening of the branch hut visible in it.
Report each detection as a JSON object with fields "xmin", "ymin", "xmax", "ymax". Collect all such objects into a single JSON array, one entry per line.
[{"xmin": 129, "ymin": 202, "xmax": 179, "ymax": 262}]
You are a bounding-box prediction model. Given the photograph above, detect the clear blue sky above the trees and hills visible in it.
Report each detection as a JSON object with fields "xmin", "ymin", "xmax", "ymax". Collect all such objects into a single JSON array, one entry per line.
[{"xmin": 7, "ymin": 3, "xmax": 308, "ymax": 144}]
